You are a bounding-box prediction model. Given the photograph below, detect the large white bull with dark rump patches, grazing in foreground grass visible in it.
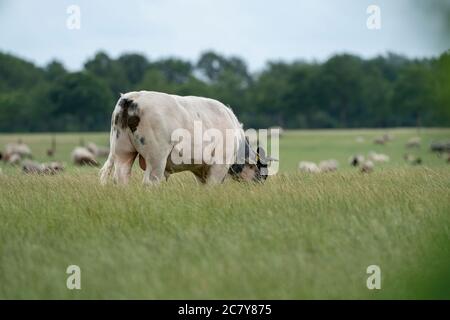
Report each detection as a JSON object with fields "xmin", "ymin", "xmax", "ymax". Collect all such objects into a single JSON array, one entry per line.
[{"xmin": 100, "ymin": 91, "xmax": 267, "ymax": 185}]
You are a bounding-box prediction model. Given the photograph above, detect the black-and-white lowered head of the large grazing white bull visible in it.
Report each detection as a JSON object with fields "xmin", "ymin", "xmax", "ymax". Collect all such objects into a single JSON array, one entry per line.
[{"xmin": 228, "ymin": 139, "xmax": 277, "ymax": 182}]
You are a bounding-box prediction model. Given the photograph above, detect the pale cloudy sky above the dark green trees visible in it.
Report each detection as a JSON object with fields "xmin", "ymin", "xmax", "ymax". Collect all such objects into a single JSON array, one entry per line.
[{"xmin": 0, "ymin": 0, "xmax": 449, "ymax": 70}]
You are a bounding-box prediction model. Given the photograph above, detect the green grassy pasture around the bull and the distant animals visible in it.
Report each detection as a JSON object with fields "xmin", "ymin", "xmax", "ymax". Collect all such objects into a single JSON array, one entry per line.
[{"xmin": 0, "ymin": 129, "xmax": 450, "ymax": 299}]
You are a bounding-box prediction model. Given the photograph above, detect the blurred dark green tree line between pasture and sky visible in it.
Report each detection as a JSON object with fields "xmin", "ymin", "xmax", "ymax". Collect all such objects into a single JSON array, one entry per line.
[{"xmin": 0, "ymin": 51, "xmax": 450, "ymax": 132}]
